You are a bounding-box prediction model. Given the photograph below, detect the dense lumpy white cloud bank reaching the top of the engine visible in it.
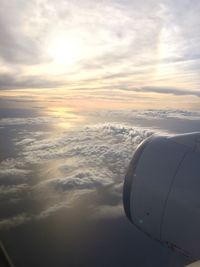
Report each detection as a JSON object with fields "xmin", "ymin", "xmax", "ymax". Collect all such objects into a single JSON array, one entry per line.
[{"xmin": 17, "ymin": 123, "xmax": 152, "ymax": 168}]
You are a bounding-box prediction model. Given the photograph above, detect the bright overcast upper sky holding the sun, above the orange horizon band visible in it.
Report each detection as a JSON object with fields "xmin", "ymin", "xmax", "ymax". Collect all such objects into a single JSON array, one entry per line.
[{"xmin": 0, "ymin": 0, "xmax": 200, "ymax": 104}]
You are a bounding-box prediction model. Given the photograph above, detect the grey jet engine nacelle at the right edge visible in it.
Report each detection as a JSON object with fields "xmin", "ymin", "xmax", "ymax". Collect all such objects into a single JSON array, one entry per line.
[{"xmin": 123, "ymin": 133, "xmax": 200, "ymax": 259}]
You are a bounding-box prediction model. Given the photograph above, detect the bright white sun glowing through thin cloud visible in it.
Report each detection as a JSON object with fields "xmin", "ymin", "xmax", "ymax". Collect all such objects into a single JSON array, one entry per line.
[{"xmin": 48, "ymin": 37, "xmax": 81, "ymax": 66}]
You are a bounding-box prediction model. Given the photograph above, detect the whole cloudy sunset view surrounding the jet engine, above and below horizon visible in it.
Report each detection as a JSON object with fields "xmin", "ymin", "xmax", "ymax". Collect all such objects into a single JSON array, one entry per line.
[{"xmin": 0, "ymin": 0, "xmax": 200, "ymax": 267}]
